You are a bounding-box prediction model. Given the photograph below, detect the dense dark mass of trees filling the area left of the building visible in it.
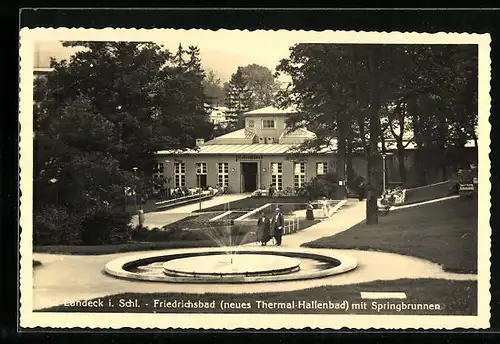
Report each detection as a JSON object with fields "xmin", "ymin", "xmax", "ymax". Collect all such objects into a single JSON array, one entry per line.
[{"xmin": 33, "ymin": 42, "xmax": 212, "ymax": 244}]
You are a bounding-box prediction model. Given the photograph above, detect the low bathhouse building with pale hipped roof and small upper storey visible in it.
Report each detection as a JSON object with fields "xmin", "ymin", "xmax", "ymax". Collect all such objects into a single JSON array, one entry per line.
[{"xmin": 157, "ymin": 107, "xmax": 366, "ymax": 192}]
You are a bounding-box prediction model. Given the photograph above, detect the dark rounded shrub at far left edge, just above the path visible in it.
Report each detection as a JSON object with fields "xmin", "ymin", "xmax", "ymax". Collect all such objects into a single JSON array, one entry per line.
[{"xmin": 33, "ymin": 206, "xmax": 82, "ymax": 245}]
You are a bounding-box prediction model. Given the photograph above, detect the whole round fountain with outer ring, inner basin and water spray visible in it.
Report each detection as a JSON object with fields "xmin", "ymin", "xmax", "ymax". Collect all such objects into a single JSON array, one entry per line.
[{"xmin": 105, "ymin": 200, "xmax": 357, "ymax": 283}]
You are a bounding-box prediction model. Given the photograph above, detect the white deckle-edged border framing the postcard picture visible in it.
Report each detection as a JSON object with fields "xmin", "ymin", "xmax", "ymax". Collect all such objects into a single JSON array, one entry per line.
[{"xmin": 19, "ymin": 28, "xmax": 491, "ymax": 329}]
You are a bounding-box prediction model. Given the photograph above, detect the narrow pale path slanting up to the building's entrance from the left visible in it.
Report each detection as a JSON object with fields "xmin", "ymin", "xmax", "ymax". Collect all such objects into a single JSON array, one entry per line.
[{"xmin": 132, "ymin": 194, "xmax": 250, "ymax": 228}]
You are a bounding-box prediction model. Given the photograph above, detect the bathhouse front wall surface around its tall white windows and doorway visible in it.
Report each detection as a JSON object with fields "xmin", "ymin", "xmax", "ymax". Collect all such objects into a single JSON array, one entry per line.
[{"xmin": 158, "ymin": 155, "xmax": 366, "ymax": 192}]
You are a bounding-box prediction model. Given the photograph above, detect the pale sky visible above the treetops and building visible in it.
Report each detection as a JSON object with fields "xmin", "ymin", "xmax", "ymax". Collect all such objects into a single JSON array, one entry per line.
[{"xmin": 35, "ymin": 30, "xmax": 304, "ymax": 81}]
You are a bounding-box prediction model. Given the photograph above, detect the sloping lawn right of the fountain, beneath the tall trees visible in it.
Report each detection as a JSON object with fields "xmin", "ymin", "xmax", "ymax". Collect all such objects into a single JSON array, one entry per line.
[{"xmin": 302, "ymin": 197, "xmax": 478, "ymax": 273}]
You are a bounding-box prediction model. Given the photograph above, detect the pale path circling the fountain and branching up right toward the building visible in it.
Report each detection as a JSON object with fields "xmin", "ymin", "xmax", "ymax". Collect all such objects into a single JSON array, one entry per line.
[{"xmin": 33, "ymin": 200, "xmax": 477, "ymax": 309}]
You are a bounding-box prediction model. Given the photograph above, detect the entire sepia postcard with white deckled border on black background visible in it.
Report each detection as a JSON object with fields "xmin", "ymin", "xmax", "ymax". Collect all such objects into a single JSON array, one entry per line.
[{"xmin": 19, "ymin": 28, "xmax": 491, "ymax": 329}]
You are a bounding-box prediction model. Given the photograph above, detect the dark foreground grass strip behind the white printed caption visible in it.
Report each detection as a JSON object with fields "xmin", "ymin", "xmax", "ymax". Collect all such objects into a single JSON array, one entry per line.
[{"xmin": 40, "ymin": 279, "xmax": 477, "ymax": 315}]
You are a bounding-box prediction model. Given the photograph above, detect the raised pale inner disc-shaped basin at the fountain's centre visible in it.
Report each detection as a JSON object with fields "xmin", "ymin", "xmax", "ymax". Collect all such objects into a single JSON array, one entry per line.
[{"xmin": 163, "ymin": 254, "xmax": 300, "ymax": 278}]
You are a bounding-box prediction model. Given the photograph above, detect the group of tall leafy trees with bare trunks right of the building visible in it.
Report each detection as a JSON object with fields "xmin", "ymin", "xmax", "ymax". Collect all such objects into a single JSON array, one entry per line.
[{"xmin": 277, "ymin": 44, "xmax": 477, "ymax": 223}]
